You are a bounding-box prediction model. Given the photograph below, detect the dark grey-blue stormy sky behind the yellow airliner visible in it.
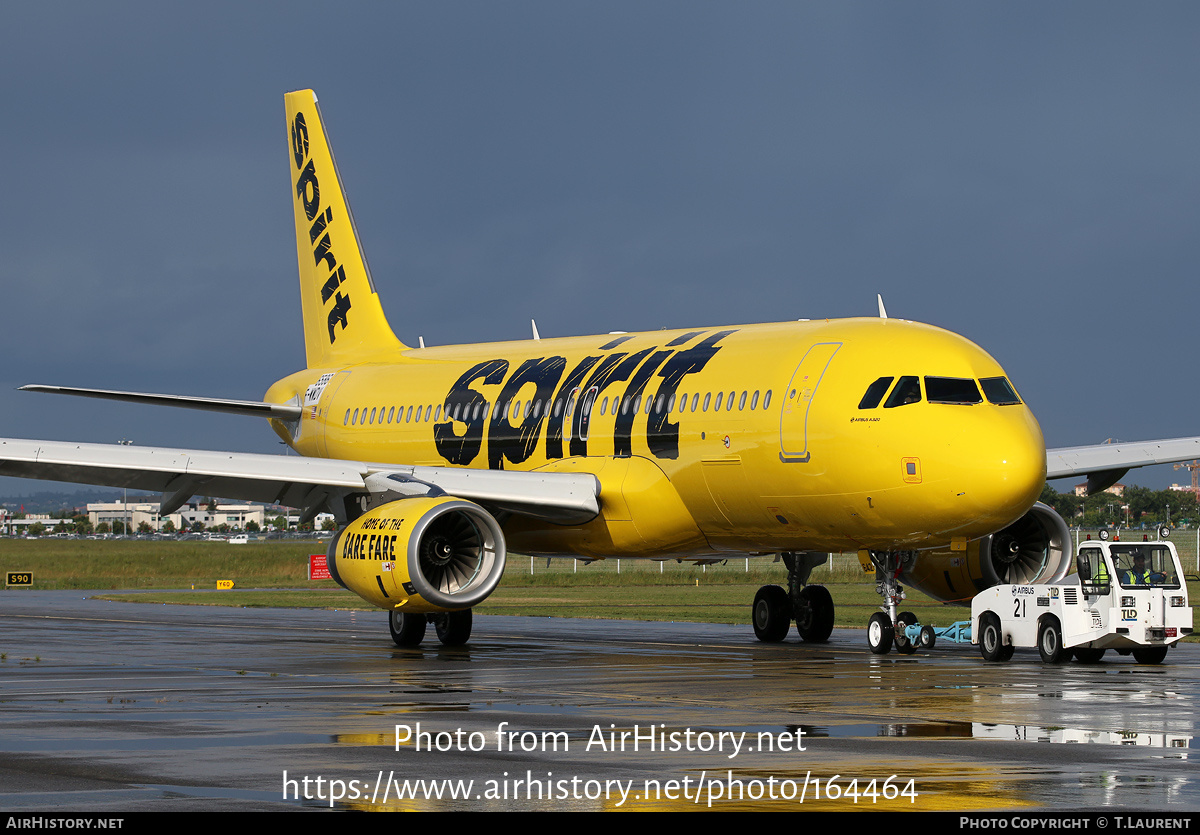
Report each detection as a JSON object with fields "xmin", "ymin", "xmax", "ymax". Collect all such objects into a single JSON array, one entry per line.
[{"xmin": 0, "ymin": 0, "xmax": 1200, "ymax": 492}]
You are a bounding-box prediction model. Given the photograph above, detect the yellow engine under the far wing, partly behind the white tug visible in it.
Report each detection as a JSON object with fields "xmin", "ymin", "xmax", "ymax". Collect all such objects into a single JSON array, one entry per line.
[{"xmin": 902, "ymin": 501, "xmax": 1072, "ymax": 602}]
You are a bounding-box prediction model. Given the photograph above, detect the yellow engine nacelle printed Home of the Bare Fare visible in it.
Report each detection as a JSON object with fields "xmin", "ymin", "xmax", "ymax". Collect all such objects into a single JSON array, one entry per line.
[{"xmin": 328, "ymin": 495, "xmax": 505, "ymax": 613}]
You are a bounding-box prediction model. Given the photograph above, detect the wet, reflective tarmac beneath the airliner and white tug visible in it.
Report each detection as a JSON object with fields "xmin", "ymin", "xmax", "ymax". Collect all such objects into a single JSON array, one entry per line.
[{"xmin": 0, "ymin": 591, "xmax": 1200, "ymax": 812}]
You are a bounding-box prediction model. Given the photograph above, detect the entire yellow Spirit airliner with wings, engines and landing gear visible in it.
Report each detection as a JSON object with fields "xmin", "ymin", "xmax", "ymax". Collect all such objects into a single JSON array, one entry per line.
[{"xmin": 9, "ymin": 90, "xmax": 1200, "ymax": 653}]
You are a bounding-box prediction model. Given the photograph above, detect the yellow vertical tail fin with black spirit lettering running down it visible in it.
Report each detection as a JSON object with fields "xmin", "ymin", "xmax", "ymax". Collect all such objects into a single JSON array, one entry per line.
[{"xmin": 283, "ymin": 90, "xmax": 406, "ymax": 368}]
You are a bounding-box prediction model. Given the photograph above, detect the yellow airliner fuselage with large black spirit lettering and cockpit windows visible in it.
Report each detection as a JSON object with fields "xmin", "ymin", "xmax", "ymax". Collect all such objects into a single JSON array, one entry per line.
[{"xmin": 266, "ymin": 318, "xmax": 1045, "ymax": 557}]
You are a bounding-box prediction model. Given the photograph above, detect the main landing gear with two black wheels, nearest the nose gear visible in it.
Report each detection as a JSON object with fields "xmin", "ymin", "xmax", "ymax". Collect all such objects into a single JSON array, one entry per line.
[{"xmin": 752, "ymin": 552, "xmax": 833, "ymax": 643}]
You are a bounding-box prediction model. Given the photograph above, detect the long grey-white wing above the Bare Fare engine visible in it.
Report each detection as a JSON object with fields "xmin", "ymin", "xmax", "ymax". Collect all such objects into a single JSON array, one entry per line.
[{"xmin": 0, "ymin": 438, "xmax": 600, "ymax": 524}]
